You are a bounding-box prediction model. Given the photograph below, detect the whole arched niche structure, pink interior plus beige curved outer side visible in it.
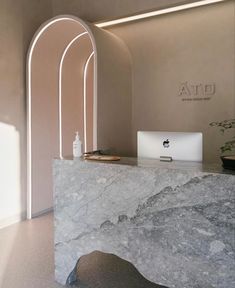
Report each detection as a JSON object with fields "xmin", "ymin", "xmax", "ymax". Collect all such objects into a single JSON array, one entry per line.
[{"xmin": 27, "ymin": 15, "xmax": 131, "ymax": 218}]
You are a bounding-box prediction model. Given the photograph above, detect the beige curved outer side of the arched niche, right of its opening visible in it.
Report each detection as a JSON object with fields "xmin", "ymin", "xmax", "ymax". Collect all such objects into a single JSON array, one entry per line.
[{"xmin": 90, "ymin": 26, "xmax": 132, "ymax": 156}]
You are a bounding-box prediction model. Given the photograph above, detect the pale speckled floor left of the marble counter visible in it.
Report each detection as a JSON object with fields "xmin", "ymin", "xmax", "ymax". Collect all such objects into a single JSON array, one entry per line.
[{"xmin": 0, "ymin": 214, "xmax": 63, "ymax": 288}]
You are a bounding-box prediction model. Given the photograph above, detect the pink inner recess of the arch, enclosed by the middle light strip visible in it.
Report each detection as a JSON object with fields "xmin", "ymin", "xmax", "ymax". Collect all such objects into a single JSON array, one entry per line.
[{"xmin": 59, "ymin": 34, "xmax": 96, "ymax": 157}]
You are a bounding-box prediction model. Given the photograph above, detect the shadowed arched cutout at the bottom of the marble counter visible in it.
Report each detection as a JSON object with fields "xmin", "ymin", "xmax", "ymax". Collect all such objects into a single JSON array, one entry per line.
[{"xmin": 66, "ymin": 251, "xmax": 167, "ymax": 288}]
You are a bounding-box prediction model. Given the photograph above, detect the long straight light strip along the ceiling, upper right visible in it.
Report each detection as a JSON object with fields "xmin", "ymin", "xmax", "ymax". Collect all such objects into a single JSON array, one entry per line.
[{"xmin": 95, "ymin": 0, "xmax": 226, "ymax": 28}]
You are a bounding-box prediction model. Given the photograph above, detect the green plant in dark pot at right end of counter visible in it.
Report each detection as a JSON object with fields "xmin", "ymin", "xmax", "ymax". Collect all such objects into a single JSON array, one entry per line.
[{"xmin": 210, "ymin": 119, "xmax": 235, "ymax": 170}]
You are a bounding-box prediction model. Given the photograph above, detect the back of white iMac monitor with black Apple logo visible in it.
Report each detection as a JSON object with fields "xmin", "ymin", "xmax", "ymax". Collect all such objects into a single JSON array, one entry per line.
[{"xmin": 137, "ymin": 131, "xmax": 202, "ymax": 162}]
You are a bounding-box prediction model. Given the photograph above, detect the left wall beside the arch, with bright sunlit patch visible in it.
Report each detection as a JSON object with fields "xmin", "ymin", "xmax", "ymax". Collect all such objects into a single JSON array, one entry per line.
[{"xmin": 0, "ymin": 0, "xmax": 52, "ymax": 226}]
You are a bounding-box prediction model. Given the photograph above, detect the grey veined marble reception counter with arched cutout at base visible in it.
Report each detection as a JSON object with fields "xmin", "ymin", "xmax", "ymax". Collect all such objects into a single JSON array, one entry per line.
[{"xmin": 53, "ymin": 158, "xmax": 235, "ymax": 288}]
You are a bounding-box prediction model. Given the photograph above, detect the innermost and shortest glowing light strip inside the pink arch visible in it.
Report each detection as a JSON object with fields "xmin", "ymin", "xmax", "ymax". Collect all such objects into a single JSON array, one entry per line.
[{"xmin": 83, "ymin": 51, "xmax": 94, "ymax": 152}]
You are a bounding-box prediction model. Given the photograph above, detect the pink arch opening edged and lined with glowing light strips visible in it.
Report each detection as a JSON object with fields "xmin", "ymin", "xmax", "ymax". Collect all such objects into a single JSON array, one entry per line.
[{"xmin": 27, "ymin": 16, "xmax": 97, "ymax": 219}]
